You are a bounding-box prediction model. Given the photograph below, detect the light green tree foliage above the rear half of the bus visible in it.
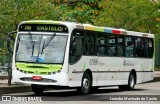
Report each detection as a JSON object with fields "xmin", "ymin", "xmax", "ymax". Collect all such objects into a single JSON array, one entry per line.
[{"xmin": 94, "ymin": 0, "xmax": 159, "ymax": 32}]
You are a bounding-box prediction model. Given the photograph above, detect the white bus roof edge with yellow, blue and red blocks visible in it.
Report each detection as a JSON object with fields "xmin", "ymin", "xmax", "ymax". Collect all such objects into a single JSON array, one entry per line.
[{"xmin": 20, "ymin": 20, "xmax": 154, "ymax": 38}]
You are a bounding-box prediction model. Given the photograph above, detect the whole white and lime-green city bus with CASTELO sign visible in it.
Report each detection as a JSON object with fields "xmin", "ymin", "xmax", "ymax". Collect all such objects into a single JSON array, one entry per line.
[{"xmin": 12, "ymin": 20, "xmax": 154, "ymax": 94}]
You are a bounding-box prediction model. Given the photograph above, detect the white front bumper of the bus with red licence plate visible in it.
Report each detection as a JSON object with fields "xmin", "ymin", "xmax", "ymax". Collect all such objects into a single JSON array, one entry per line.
[{"xmin": 12, "ymin": 69, "xmax": 68, "ymax": 86}]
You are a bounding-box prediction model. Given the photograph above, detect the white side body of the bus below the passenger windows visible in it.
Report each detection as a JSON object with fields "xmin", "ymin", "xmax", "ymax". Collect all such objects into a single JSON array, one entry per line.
[{"xmin": 69, "ymin": 28, "xmax": 154, "ymax": 87}]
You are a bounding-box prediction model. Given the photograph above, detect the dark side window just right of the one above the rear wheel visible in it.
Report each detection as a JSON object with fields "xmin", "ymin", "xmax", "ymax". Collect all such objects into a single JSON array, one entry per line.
[{"xmin": 135, "ymin": 37, "xmax": 144, "ymax": 57}]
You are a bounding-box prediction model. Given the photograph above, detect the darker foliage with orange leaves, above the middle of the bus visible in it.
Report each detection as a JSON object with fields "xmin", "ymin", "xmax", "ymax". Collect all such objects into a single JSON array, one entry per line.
[{"xmin": 50, "ymin": 0, "xmax": 101, "ymax": 23}]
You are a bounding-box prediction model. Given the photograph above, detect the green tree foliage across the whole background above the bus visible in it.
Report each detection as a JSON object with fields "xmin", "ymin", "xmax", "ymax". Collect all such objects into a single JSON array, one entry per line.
[{"xmin": 0, "ymin": 0, "xmax": 160, "ymax": 33}]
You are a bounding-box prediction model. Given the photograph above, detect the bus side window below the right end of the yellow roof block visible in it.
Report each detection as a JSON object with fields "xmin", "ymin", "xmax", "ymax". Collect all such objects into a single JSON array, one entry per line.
[{"xmin": 97, "ymin": 33, "xmax": 106, "ymax": 56}]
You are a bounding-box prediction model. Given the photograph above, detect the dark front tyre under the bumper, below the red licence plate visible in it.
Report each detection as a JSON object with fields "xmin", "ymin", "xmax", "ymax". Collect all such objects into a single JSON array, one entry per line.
[{"xmin": 31, "ymin": 84, "xmax": 44, "ymax": 95}]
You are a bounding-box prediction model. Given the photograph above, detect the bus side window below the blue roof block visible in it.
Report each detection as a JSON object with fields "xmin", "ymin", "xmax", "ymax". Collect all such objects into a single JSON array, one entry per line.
[{"xmin": 108, "ymin": 35, "xmax": 117, "ymax": 56}]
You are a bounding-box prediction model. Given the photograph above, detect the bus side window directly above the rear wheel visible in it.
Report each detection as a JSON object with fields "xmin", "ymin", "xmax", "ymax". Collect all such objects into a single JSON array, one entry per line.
[{"xmin": 125, "ymin": 36, "xmax": 134, "ymax": 57}]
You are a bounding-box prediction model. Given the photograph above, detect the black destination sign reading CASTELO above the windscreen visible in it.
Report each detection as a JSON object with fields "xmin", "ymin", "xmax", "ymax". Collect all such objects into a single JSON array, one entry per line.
[{"xmin": 19, "ymin": 24, "xmax": 68, "ymax": 33}]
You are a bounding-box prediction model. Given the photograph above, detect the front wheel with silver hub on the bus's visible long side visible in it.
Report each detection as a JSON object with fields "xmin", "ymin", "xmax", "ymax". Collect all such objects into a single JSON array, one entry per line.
[{"xmin": 79, "ymin": 73, "xmax": 92, "ymax": 95}]
